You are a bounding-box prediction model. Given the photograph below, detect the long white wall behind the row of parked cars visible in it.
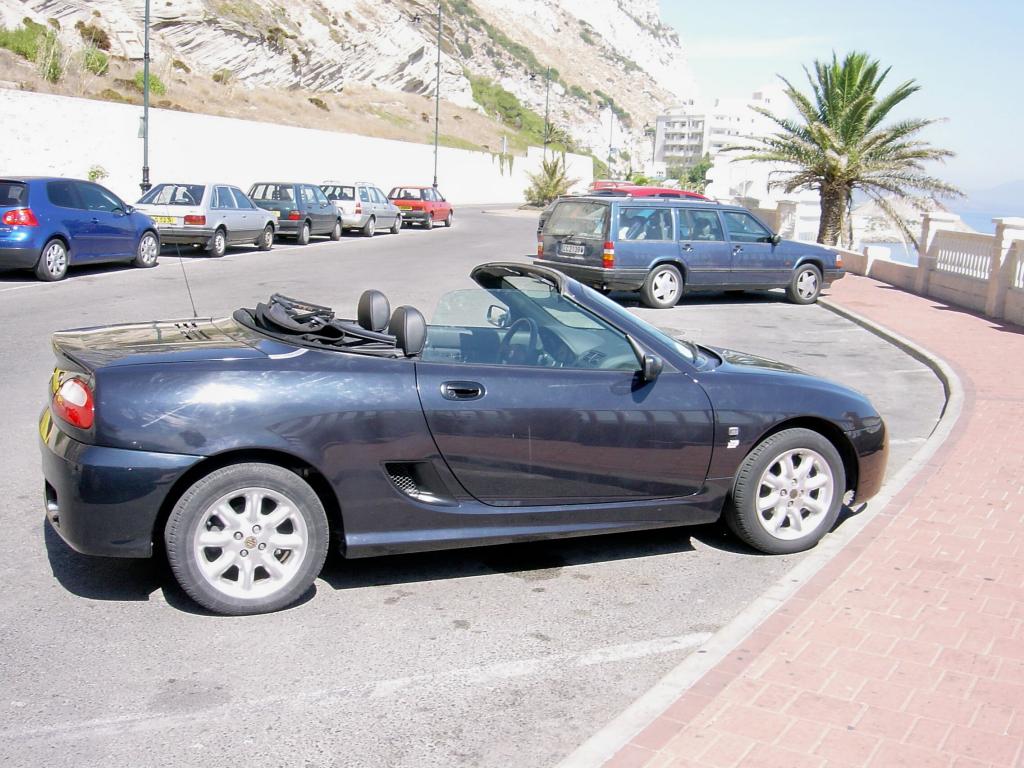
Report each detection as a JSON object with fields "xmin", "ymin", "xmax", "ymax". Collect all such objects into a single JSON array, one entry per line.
[{"xmin": 0, "ymin": 89, "xmax": 593, "ymax": 204}]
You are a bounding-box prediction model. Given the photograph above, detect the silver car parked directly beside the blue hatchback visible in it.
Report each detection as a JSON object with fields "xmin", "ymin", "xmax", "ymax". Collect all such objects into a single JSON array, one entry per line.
[{"xmin": 136, "ymin": 183, "xmax": 278, "ymax": 256}]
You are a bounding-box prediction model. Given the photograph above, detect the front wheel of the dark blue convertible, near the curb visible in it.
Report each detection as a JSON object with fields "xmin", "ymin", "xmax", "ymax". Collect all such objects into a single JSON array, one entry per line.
[{"xmin": 725, "ymin": 429, "xmax": 846, "ymax": 554}]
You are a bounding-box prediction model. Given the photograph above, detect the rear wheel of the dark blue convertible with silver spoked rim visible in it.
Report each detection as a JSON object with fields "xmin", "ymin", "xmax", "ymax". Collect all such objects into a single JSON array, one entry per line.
[{"xmin": 164, "ymin": 464, "xmax": 329, "ymax": 614}]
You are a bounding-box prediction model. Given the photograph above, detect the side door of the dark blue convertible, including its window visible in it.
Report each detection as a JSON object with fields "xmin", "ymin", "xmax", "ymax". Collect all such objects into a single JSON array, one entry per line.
[{"xmin": 416, "ymin": 292, "xmax": 714, "ymax": 507}]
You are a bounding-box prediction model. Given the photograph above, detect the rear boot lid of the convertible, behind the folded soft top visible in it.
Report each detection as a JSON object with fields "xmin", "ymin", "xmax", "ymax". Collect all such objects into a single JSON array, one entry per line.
[{"xmin": 52, "ymin": 318, "xmax": 266, "ymax": 371}]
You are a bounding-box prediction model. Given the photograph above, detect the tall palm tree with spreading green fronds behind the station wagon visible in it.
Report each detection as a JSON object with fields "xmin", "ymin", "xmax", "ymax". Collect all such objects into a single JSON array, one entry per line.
[{"xmin": 730, "ymin": 51, "xmax": 963, "ymax": 245}]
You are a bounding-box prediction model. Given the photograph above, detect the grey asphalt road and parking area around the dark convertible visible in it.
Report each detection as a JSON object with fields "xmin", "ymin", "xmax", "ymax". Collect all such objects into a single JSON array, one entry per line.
[{"xmin": 0, "ymin": 209, "xmax": 942, "ymax": 768}]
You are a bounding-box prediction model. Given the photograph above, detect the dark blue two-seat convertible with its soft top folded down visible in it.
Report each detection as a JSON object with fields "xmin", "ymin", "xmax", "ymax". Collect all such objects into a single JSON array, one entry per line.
[{"xmin": 39, "ymin": 263, "xmax": 888, "ymax": 613}]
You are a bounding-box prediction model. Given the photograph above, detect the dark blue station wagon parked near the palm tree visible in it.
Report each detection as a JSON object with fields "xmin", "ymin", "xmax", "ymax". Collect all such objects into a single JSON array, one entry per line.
[{"xmin": 536, "ymin": 197, "xmax": 845, "ymax": 309}]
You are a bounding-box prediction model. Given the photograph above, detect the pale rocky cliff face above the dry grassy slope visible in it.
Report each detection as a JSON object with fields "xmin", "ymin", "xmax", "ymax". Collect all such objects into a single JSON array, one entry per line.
[{"xmin": 0, "ymin": 0, "xmax": 694, "ymax": 162}]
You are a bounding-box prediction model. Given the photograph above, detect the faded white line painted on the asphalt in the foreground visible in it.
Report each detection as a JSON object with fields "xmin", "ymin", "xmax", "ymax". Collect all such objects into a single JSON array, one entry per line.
[{"xmin": 0, "ymin": 632, "xmax": 712, "ymax": 742}]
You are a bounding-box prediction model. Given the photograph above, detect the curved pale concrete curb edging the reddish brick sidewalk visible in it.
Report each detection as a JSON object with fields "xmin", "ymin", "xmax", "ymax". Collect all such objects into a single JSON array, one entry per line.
[{"xmin": 557, "ymin": 299, "xmax": 964, "ymax": 768}]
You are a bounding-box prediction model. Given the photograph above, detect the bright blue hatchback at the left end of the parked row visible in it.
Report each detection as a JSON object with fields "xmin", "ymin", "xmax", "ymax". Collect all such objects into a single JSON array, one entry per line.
[{"xmin": 0, "ymin": 176, "xmax": 160, "ymax": 281}]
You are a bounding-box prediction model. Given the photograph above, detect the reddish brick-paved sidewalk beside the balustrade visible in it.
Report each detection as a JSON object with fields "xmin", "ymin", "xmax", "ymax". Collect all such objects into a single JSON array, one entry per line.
[{"xmin": 589, "ymin": 275, "xmax": 1024, "ymax": 768}]
